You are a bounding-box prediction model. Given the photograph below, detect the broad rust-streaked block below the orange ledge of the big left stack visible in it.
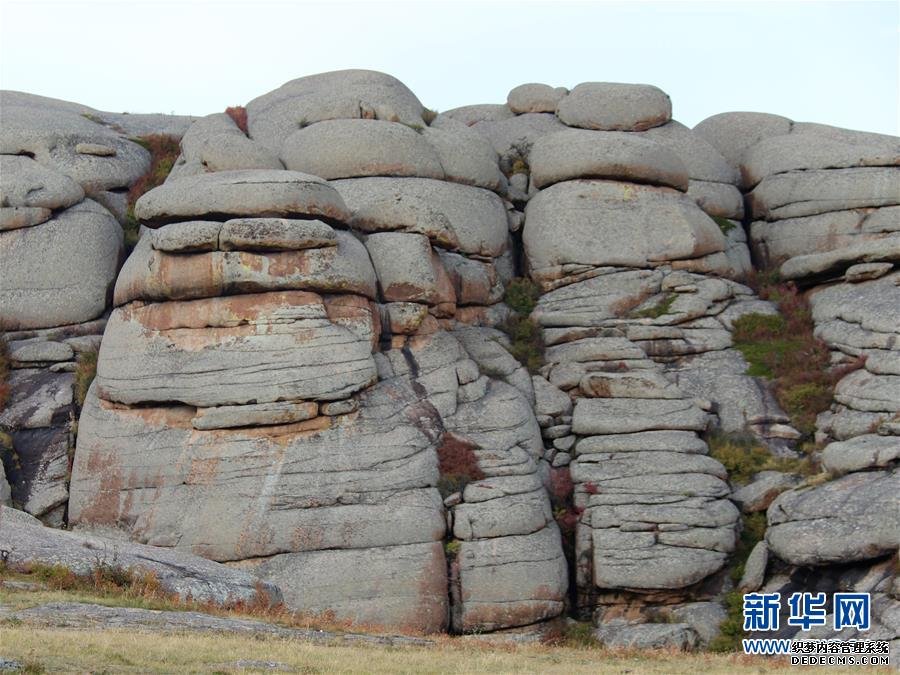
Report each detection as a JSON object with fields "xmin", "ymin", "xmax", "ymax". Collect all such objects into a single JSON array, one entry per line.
[{"xmin": 69, "ymin": 379, "xmax": 445, "ymax": 564}]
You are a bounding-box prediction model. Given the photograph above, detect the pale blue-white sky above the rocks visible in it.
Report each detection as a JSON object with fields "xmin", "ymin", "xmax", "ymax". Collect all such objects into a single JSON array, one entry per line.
[{"xmin": 0, "ymin": 0, "xmax": 900, "ymax": 135}]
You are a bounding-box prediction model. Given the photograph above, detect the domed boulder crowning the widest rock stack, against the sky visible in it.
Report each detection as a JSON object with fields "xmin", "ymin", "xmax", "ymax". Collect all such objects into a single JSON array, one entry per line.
[{"xmin": 247, "ymin": 70, "xmax": 424, "ymax": 155}]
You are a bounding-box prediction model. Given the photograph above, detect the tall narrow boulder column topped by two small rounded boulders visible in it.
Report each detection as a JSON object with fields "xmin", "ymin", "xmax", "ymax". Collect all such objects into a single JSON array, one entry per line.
[{"xmin": 464, "ymin": 83, "xmax": 808, "ymax": 647}]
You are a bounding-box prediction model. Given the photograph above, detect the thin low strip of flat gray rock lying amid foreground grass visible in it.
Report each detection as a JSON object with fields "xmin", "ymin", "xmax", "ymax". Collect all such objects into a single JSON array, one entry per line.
[{"xmin": 3, "ymin": 602, "xmax": 433, "ymax": 648}]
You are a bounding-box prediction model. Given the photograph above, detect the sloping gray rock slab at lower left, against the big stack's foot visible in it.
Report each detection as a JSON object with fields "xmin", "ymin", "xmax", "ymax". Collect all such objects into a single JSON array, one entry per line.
[{"xmin": 0, "ymin": 506, "xmax": 281, "ymax": 605}]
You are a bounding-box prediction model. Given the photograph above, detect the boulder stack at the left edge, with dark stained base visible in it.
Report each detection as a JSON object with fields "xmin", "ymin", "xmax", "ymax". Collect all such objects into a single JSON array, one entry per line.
[{"xmin": 0, "ymin": 92, "xmax": 157, "ymax": 526}]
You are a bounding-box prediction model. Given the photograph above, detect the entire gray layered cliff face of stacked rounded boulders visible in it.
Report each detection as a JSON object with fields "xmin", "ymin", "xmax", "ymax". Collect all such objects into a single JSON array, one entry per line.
[{"xmin": 0, "ymin": 71, "xmax": 900, "ymax": 647}]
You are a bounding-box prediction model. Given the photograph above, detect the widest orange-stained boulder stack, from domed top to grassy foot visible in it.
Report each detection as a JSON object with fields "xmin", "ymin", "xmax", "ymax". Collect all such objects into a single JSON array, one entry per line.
[{"xmin": 70, "ymin": 71, "xmax": 567, "ymax": 632}]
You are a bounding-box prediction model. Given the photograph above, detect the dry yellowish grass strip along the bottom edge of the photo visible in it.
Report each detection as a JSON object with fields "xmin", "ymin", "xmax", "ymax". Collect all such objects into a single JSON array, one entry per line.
[{"xmin": 3, "ymin": 625, "xmax": 844, "ymax": 674}]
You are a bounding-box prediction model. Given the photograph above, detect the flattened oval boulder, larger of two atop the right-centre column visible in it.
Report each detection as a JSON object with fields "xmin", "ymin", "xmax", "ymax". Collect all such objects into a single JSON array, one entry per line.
[{"xmin": 556, "ymin": 82, "xmax": 672, "ymax": 131}]
